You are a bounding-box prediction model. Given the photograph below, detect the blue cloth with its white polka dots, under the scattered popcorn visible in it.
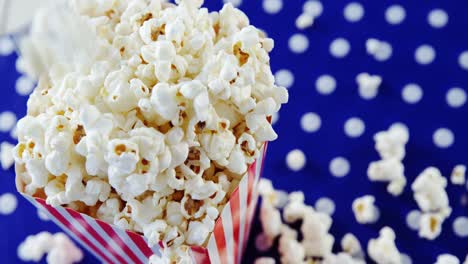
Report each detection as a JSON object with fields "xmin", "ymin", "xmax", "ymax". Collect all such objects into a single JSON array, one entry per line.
[{"xmin": 0, "ymin": 0, "xmax": 468, "ymax": 263}]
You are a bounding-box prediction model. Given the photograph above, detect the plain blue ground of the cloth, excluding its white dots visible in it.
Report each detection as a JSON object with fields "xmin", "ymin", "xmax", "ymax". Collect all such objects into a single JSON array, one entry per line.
[{"xmin": 0, "ymin": 0, "xmax": 468, "ymax": 263}]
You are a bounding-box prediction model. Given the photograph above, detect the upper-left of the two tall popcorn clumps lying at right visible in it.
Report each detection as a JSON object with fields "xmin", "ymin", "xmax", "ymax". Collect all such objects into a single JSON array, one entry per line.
[{"xmin": 367, "ymin": 124, "xmax": 409, "ymax": 196}]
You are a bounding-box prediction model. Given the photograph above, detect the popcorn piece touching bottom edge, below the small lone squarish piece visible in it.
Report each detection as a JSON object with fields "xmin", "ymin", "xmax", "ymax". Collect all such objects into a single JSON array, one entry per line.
[{"xmin": 367, "ymin": 226, "xmax": 401, "ymax": 264}]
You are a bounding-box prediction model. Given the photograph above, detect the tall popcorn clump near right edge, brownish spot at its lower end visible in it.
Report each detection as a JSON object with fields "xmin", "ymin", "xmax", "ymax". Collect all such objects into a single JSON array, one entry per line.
[{"xmin": 411, "ymin": 167, "xmax": 452, "ymax": 240}]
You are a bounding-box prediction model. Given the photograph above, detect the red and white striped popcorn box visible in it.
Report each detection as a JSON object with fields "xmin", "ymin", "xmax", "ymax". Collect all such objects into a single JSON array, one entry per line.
[{"xmin": 18, "ymin": 144, "xmax": 266, "ymax": 264}]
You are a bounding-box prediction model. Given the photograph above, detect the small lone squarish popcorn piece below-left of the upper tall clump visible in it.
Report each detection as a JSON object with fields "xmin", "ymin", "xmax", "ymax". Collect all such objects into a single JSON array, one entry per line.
[{"xmin": 352, "ymin": 195, "xmax": 379, "ymax": 224}]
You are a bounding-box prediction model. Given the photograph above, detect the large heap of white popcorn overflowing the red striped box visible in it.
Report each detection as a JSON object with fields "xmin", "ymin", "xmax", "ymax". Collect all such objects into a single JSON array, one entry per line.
[{"xmin": 14, "ymin": 0, "xmax": 288, "ymax": 254}]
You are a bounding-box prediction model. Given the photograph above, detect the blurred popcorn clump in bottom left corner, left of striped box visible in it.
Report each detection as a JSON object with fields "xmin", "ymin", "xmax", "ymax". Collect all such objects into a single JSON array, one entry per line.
[{"xmin": 18, "ymin": 232, "xmax": 83, "ymax": 264}]
